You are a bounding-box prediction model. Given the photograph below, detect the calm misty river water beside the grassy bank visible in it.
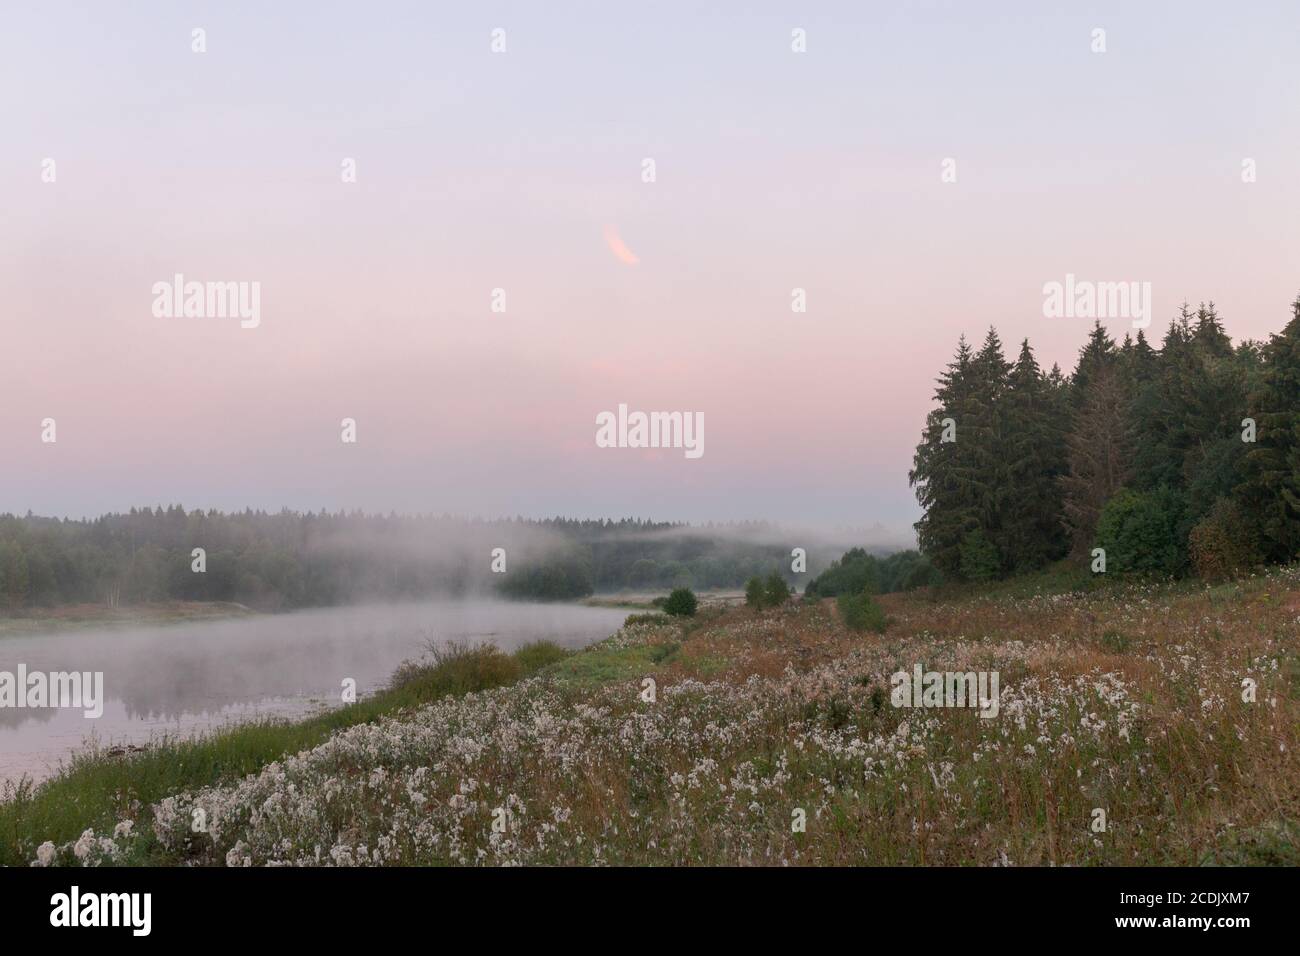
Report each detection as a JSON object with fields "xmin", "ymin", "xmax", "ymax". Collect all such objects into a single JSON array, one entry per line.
[{"xmin": 0, "ymin": 598, "xmax": 627, "ymax": 780}]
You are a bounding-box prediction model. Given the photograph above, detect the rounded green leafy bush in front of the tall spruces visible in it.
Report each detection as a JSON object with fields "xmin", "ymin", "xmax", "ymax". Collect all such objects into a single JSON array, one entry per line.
[{"xmin": 1096, "ymin": 486, "xmax": 1187, "ymax": 575}]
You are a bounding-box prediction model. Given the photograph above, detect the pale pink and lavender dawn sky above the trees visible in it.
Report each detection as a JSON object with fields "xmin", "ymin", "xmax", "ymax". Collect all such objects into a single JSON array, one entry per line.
[{"xmin": 0, "ymin": 1, "xmax": 1300, "ymax": 533}]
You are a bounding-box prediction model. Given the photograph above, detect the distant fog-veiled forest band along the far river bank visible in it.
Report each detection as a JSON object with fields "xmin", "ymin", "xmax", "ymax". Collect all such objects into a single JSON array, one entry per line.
[{"xmin": 0, "ymin": 505, "xmax": 894, "ymax": 610}]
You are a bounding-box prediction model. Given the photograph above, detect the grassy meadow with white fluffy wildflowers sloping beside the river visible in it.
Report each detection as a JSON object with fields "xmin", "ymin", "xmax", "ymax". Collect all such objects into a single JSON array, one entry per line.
[{"xmin": 0, "ymin": 567, "xmax": 1300, "ymax": 866}]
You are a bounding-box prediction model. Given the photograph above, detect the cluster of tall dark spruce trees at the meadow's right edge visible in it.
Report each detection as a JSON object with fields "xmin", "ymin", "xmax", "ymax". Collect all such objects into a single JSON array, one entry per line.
[{"xmin": 910, "ymin": 298, "xmax": 1300, "ymax": 581}]
